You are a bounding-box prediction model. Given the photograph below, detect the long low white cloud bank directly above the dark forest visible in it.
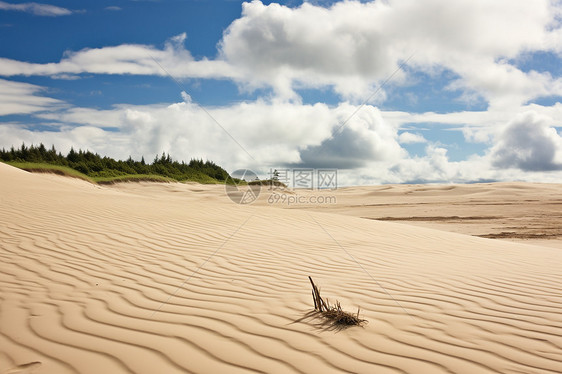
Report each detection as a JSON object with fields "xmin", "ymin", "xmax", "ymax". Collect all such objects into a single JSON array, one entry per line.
[{"xmin": 0, "ymin": 93, "xmax": 407, "ymax": 175}]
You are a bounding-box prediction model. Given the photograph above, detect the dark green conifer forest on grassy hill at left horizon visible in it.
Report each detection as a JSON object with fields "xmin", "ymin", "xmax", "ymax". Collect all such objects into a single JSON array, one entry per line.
[{"xmin": 0, "ymin": 144, "xmax": 229, "ymax": 183}]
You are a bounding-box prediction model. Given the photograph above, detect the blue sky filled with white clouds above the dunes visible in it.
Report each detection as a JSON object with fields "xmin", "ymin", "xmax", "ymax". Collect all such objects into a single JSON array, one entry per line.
[{"xmin": 0, "ymin": 0, "xmax": 562, "ymax": 184}]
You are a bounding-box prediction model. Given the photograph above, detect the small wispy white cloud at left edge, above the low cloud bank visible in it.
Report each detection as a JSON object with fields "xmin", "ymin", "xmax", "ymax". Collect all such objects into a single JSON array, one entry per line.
[{"xmin": 0, "ymin": 79, "xmax": 63, "ymax": 116}]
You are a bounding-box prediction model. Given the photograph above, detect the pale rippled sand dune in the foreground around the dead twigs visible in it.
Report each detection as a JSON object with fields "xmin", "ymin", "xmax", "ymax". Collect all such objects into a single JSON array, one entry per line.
[{"xmin": 0, "ymin": 164, "xmax": 562, "ymax": 373}]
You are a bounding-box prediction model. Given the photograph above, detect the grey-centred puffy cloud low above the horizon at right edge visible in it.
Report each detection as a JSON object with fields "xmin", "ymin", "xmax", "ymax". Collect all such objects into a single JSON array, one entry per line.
[{"xmin": 491, "ymin": 111, "xmax": 562, "ymax": 171}]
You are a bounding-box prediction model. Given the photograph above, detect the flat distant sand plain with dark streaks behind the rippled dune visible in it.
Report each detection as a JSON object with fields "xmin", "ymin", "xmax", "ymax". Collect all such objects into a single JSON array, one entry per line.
[{"xmin": 255, "ymin": 183, "xmax": 562, "ymax": 250}]
